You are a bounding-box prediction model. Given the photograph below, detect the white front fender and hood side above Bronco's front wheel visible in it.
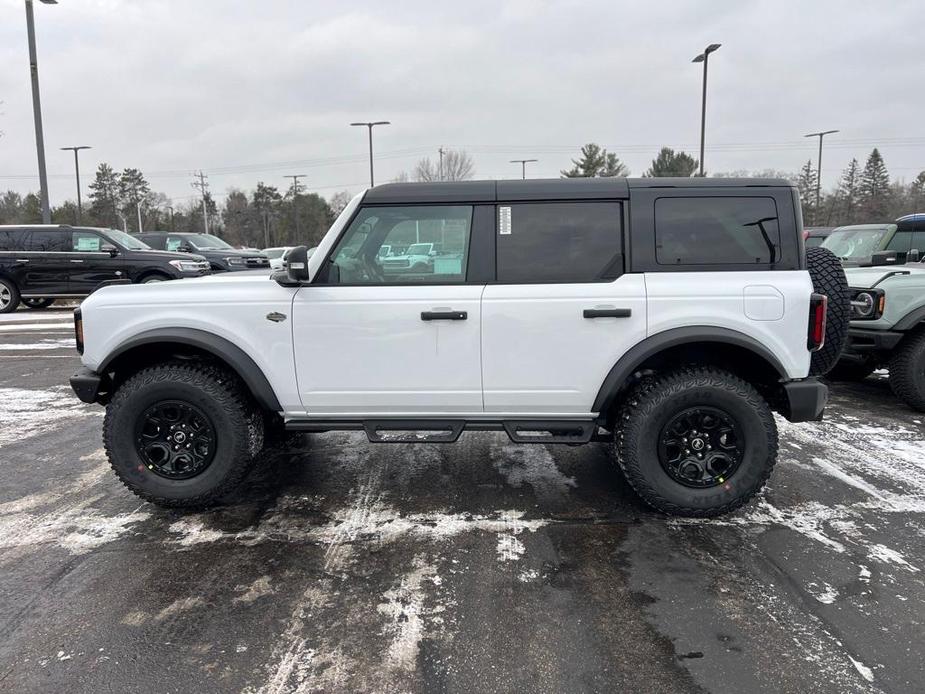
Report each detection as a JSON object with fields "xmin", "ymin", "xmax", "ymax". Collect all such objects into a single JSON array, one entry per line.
[{"xmin": 81, "ymin": 271, "xmax": 303, "ymax": 413}]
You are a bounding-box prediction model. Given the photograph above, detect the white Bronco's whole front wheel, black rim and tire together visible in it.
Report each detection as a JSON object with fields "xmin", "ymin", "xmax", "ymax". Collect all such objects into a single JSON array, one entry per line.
[{"xmin": 103, "ymin": 362, "xmax": 263, "ymax": 507}]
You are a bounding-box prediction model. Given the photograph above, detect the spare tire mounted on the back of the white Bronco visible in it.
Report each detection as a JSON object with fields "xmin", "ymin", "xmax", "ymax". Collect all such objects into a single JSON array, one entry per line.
[{"xmin": 806, "ymin": 246, "xmax": 851, "ymax": 376}]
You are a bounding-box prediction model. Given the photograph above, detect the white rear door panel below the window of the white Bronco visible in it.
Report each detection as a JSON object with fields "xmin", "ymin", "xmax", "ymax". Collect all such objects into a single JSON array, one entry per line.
[{"xmin": 482, "ymin": 275, "xmax": 646, "ymax": 414}]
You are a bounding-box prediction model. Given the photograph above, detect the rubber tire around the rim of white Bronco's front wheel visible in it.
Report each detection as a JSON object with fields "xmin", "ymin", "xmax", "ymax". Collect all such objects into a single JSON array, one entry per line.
[{"xmin": 103, "ymin": 361, "xmax": 263, "ymax": 508}]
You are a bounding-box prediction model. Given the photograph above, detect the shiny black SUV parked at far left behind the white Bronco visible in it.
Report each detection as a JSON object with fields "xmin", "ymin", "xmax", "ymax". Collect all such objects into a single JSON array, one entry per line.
[{"xmin": 0, "ymin": 225, "xmax": 209, "ymax": 313}]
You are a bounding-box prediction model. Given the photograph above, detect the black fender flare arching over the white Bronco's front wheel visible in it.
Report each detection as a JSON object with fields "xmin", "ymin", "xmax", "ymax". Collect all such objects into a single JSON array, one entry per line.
[{"xmin": 98, "ymin": 328, "xmax": 283, "ymax": 412}]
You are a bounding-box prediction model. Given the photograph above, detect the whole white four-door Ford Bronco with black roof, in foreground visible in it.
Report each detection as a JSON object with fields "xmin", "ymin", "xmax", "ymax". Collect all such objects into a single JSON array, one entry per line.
[{"xmin": 71, "ymin": 178, "xmax": 850, "ymax": 516}]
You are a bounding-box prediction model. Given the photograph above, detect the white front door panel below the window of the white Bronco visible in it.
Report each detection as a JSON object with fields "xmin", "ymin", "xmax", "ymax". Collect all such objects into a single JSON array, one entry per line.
[{"xmin": 292, "ymin": 285, "xmax": 483, "ymax": 416}]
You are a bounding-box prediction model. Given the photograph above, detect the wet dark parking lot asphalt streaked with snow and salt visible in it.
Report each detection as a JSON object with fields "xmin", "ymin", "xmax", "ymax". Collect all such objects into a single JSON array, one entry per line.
[{"xmin": 0, "ymin": 310, "xmax": 925, "ymax": 694}]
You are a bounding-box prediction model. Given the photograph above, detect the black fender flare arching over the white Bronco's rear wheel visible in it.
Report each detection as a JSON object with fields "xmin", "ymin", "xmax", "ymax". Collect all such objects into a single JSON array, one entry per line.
[{"xmin": 591, "ymin": 325, "xmax": 787, "ymax": 415}]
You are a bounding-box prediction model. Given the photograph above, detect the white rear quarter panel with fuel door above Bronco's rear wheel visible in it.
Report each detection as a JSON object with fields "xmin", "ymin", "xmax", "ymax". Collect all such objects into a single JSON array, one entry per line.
[{"xmin": 645, "ymin": 270, "xmax": 813, "ymax": 378}]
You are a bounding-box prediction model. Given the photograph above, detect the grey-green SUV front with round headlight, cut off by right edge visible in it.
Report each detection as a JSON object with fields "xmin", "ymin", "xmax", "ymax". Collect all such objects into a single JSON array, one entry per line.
[{"xmin": 830, "ymin": 252, "xmax": 925, "ymax": 412}]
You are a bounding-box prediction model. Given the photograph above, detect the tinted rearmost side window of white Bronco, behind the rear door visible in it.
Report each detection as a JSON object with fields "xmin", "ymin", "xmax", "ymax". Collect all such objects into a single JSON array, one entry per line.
[{"xmin": 655, "ymin": 197, "xmax": 780, "ymax": 265}]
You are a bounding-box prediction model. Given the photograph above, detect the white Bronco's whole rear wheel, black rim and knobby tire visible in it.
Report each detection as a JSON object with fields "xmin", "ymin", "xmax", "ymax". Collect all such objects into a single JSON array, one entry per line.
[{"xmin": 615, "ymin": 367, "xmax": 777, "ymax": 517}]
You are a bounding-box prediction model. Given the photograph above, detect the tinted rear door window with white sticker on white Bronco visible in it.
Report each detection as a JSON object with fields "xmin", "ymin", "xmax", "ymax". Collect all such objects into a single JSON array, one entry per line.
[{"xmin": 497, "ymin": 202, "xmax": 623, "ymax": 284}]
